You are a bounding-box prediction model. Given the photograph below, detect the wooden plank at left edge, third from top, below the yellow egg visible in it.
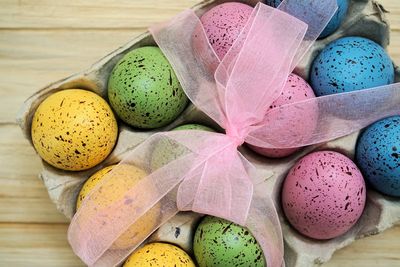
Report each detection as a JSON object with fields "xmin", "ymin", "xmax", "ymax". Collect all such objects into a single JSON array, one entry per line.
[{"xmin": 0, "ymin": 124, "xmax": 67, "ymax": 223}]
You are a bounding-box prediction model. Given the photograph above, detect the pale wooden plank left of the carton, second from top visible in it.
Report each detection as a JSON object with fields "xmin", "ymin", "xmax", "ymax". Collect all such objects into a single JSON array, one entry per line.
[{"xmin": 0, "ymin": 29, "xmax": 144, "ymax": 123}]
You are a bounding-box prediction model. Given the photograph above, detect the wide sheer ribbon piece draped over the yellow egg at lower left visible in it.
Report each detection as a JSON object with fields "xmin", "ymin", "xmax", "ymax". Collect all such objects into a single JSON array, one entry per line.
[{"xmin": 68, "ymin": 134, "xmax": 200, "ymax": 267}]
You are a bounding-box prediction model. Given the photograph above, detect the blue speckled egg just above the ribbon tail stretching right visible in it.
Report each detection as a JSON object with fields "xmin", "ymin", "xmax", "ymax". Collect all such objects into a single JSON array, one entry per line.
[{"xmin": 311, "ymin": 37, "xmax": 394, "ymax": 96}]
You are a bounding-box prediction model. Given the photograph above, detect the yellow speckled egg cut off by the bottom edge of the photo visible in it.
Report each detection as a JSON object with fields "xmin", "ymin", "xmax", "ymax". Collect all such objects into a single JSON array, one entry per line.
[{"xmin": 124, "ymin": 243, "xmax": 195, "ymax": 267}]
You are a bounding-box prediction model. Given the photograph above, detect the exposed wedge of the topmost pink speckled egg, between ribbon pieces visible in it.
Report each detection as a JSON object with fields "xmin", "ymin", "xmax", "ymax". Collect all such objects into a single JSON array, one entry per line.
[{"xmin": 200, "ymin": 2, "xmax": 253, "ymax": 59}]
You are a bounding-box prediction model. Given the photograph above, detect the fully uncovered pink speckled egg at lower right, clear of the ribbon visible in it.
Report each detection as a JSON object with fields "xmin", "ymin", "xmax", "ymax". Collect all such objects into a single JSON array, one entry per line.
[{"xmin": 282, "ymin": 151, "xmax": 366, "ymax": 239}]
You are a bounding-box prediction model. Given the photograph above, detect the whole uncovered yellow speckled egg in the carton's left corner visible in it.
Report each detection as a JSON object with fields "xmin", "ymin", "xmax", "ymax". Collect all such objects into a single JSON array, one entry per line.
[{"xmin": 31, "ymin": 89, "xmax": 118, "ymax": 171}]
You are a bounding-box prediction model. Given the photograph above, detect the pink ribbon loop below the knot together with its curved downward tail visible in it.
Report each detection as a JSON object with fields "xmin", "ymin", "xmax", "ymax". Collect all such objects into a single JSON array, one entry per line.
[{"xmin": 178, "ymin": 139, "xmax": 283, "ymax": 267}]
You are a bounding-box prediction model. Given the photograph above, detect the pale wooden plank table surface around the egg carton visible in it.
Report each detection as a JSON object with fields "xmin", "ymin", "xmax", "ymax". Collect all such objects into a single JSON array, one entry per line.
[{"xmin": 0, "ymin": 0, "xmax": 400, "ymax": 267}]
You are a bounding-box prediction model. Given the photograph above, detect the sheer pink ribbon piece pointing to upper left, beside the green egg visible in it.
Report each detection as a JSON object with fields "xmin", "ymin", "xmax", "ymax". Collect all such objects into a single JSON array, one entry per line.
[{"xmin": 150, "ymin": 10, "xmax": 224, "ymax": 125}]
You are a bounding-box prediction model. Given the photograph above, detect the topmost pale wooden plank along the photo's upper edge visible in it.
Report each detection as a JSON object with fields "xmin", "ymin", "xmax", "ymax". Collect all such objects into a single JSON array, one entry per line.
[{"xmin": 0, "ymin": 0, "xmax": 199, "ymax": 29}]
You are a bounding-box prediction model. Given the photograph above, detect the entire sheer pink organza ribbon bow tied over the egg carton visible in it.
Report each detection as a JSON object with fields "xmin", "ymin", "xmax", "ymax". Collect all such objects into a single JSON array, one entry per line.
[{"xmin": 68, "ymin": 0, "xmax": 400, "ymax": 267}]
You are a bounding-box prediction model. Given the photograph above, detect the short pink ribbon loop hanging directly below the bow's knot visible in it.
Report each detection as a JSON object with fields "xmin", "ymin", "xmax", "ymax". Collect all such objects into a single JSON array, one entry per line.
[{"xmin": 178, "ymin": 139, "xmax": 253, "ymax": 225}]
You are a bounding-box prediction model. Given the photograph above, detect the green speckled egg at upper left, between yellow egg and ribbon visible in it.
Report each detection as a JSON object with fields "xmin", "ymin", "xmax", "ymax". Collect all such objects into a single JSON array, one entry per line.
[{"xmin": 108, "ymin": 46, "xmax": 188, "ymax": 129}]
